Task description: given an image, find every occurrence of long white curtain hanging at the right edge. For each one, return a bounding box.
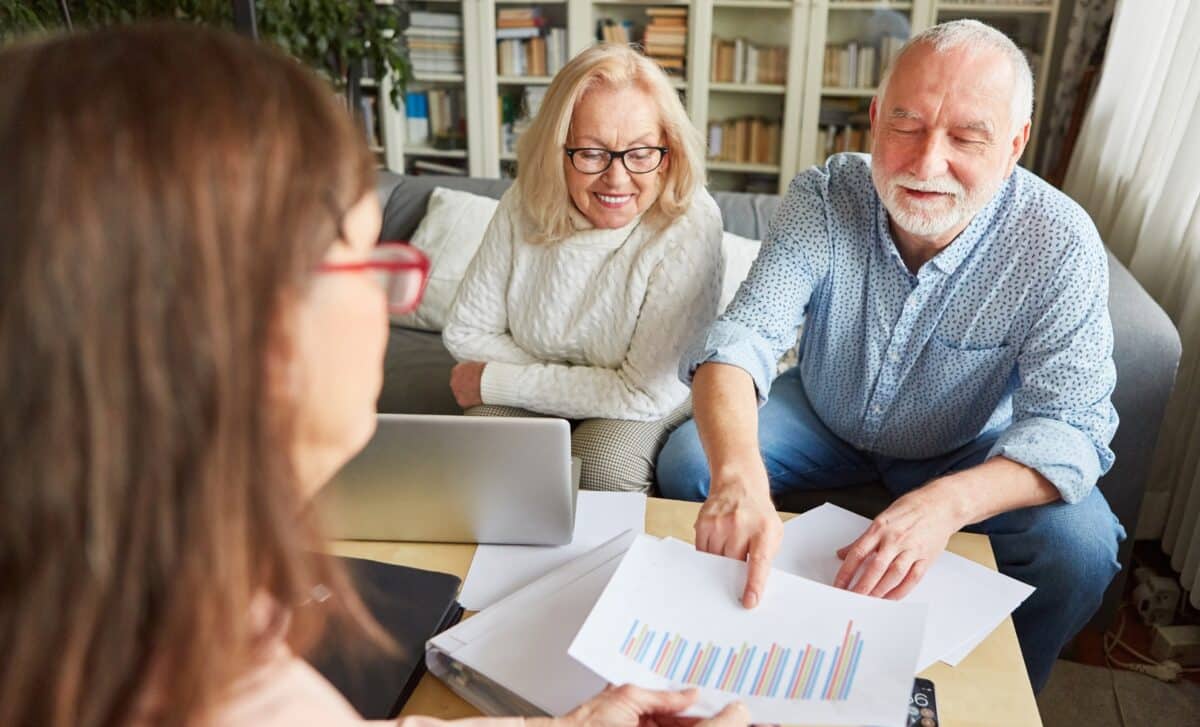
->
[1063,0,1200,607]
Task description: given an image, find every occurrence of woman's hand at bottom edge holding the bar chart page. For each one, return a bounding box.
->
[547,684,750,727]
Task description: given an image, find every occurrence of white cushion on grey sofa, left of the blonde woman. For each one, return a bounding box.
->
[391,187,499,331]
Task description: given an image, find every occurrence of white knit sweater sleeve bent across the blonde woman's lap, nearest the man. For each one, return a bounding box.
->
[481,191,724,421]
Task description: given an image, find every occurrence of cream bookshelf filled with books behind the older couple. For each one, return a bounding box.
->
[374,0,1061,193]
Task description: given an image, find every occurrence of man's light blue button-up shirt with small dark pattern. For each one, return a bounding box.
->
[680,154,1117,503]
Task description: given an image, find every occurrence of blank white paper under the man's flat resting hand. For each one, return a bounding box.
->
[775,503,1033,671]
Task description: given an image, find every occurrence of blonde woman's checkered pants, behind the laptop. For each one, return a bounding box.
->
[464,398,691,492]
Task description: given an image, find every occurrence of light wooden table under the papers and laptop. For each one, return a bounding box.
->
[331,498,1042,727]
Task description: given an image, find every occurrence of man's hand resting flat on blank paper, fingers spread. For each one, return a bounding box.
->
[833,485,965,600]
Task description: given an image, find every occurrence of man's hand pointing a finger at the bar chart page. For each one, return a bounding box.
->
[696,464,784,608]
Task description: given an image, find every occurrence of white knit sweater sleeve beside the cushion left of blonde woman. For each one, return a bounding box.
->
[442,190,538,365]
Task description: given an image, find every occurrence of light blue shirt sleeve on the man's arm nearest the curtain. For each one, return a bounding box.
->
[988,236,1117,503]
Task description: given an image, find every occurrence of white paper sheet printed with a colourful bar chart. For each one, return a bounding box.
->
[569,535,925,726]
